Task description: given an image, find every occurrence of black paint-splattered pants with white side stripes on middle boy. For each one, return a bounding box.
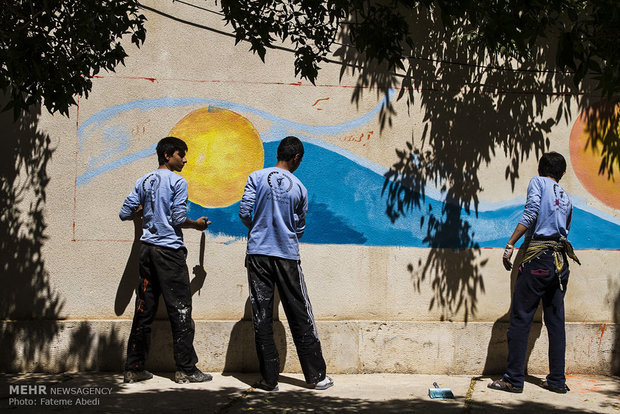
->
[246,254,326,385]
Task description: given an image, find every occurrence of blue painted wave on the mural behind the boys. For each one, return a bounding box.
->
[188,142,620,249]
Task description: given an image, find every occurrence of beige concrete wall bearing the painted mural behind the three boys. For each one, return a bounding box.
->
[0,1,620,373]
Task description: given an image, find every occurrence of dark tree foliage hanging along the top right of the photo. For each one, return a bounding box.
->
[221,0,620,96]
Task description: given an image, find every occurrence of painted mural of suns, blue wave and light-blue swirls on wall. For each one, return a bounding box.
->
[76,92,620,249]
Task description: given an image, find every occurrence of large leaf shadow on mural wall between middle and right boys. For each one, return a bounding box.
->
[336,7,596,372]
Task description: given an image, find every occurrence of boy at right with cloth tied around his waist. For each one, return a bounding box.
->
[489,152,579,393]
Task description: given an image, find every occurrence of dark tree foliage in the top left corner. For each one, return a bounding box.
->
[0,0,146,117]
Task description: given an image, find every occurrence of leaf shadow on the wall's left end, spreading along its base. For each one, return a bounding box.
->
[0,98,124,372]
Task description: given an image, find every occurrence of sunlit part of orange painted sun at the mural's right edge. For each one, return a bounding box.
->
[570,107,620,209]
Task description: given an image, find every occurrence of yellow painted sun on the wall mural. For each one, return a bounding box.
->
[169,106,264,207]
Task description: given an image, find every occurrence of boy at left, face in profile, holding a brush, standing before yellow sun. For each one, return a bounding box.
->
[119,137,212,383]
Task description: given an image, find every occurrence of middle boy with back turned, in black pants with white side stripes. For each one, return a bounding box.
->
[239,136,333,391]
